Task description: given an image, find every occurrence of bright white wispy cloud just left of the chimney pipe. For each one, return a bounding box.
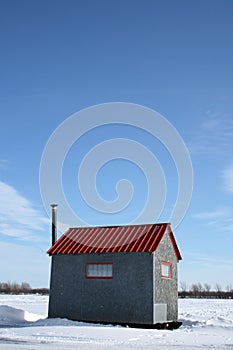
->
[0,181,49,242]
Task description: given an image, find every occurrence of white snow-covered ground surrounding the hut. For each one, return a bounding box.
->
[0,295,233,350]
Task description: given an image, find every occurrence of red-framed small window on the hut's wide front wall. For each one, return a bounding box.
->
[86,262,112,279]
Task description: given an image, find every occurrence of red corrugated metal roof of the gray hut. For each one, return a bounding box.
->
[48,223,181,260]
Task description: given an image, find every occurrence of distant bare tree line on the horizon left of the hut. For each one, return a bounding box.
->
[0,281,49,294]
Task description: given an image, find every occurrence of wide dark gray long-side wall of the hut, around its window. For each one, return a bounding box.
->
[49,253,153,324]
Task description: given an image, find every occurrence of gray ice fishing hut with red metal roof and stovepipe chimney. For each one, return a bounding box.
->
[48,208,181,326]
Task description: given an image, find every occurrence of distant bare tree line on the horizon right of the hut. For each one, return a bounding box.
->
[178,281,233,299]
